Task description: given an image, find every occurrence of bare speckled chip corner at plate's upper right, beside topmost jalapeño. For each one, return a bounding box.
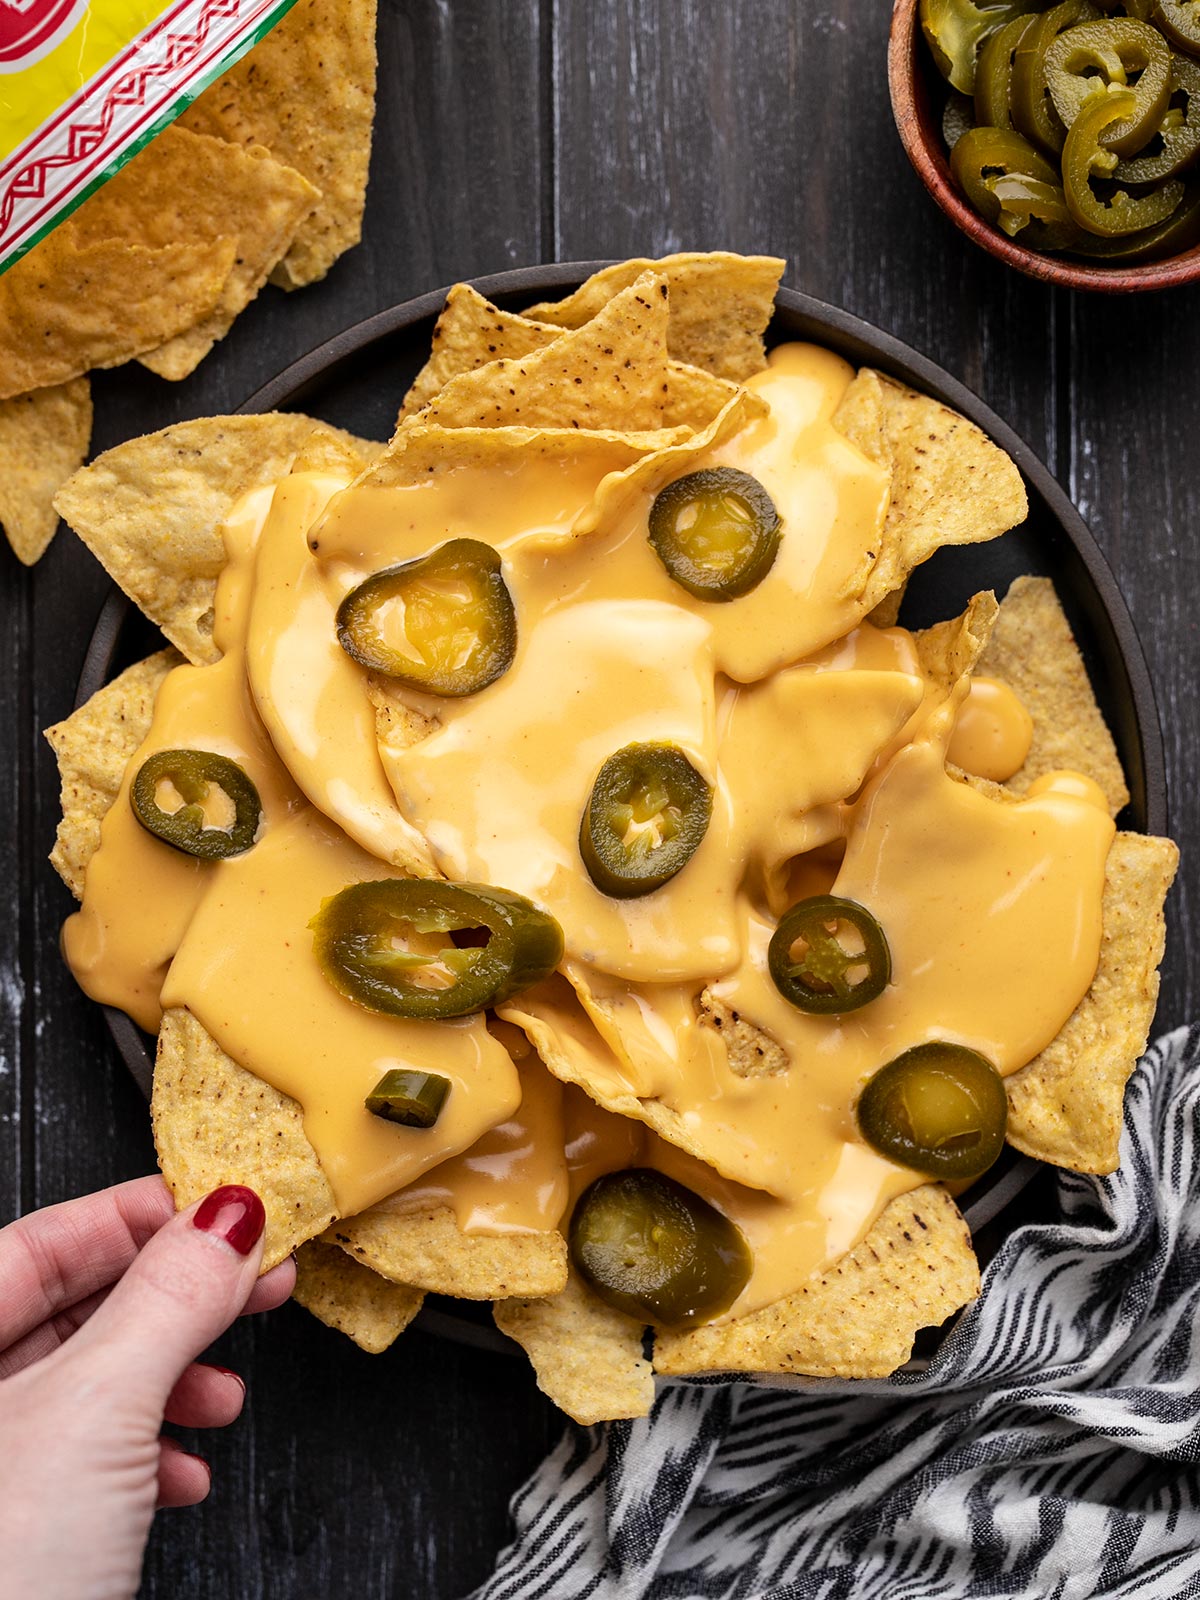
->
[834,368,1029,608]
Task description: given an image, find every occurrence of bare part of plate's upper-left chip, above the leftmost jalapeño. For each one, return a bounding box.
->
[52,419,376,666]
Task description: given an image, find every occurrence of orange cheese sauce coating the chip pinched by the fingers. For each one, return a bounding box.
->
[163,808,520,1216]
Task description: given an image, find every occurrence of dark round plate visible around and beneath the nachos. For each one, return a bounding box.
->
[77,261,1166,1352]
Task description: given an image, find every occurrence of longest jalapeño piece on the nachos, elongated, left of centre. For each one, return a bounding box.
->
[310,878,563,1022]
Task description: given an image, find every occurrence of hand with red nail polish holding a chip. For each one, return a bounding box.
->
[0,1178,296,1600]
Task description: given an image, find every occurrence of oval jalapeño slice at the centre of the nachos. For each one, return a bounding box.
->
[579,744,712,899]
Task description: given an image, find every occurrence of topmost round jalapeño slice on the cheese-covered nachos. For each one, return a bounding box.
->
[650,467,782,600]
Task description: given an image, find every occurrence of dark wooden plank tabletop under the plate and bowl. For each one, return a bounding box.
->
[0,0,1200,1600]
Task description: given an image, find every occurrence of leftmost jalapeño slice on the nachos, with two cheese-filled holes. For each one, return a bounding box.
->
[130,750,262,861]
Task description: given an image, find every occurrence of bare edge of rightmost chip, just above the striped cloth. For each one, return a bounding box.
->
[1005,834,1179,1173]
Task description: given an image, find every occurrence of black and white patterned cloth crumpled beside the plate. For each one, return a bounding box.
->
[475,1029,1200,1600]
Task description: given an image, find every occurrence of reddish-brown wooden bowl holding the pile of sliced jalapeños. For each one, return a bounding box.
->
[888,0,1200,294]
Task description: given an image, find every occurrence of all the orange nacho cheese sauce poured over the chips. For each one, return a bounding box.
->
[64,344,1114,1315]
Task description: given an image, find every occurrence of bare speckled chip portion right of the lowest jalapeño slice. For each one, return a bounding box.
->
[654,1184,979,1378]
